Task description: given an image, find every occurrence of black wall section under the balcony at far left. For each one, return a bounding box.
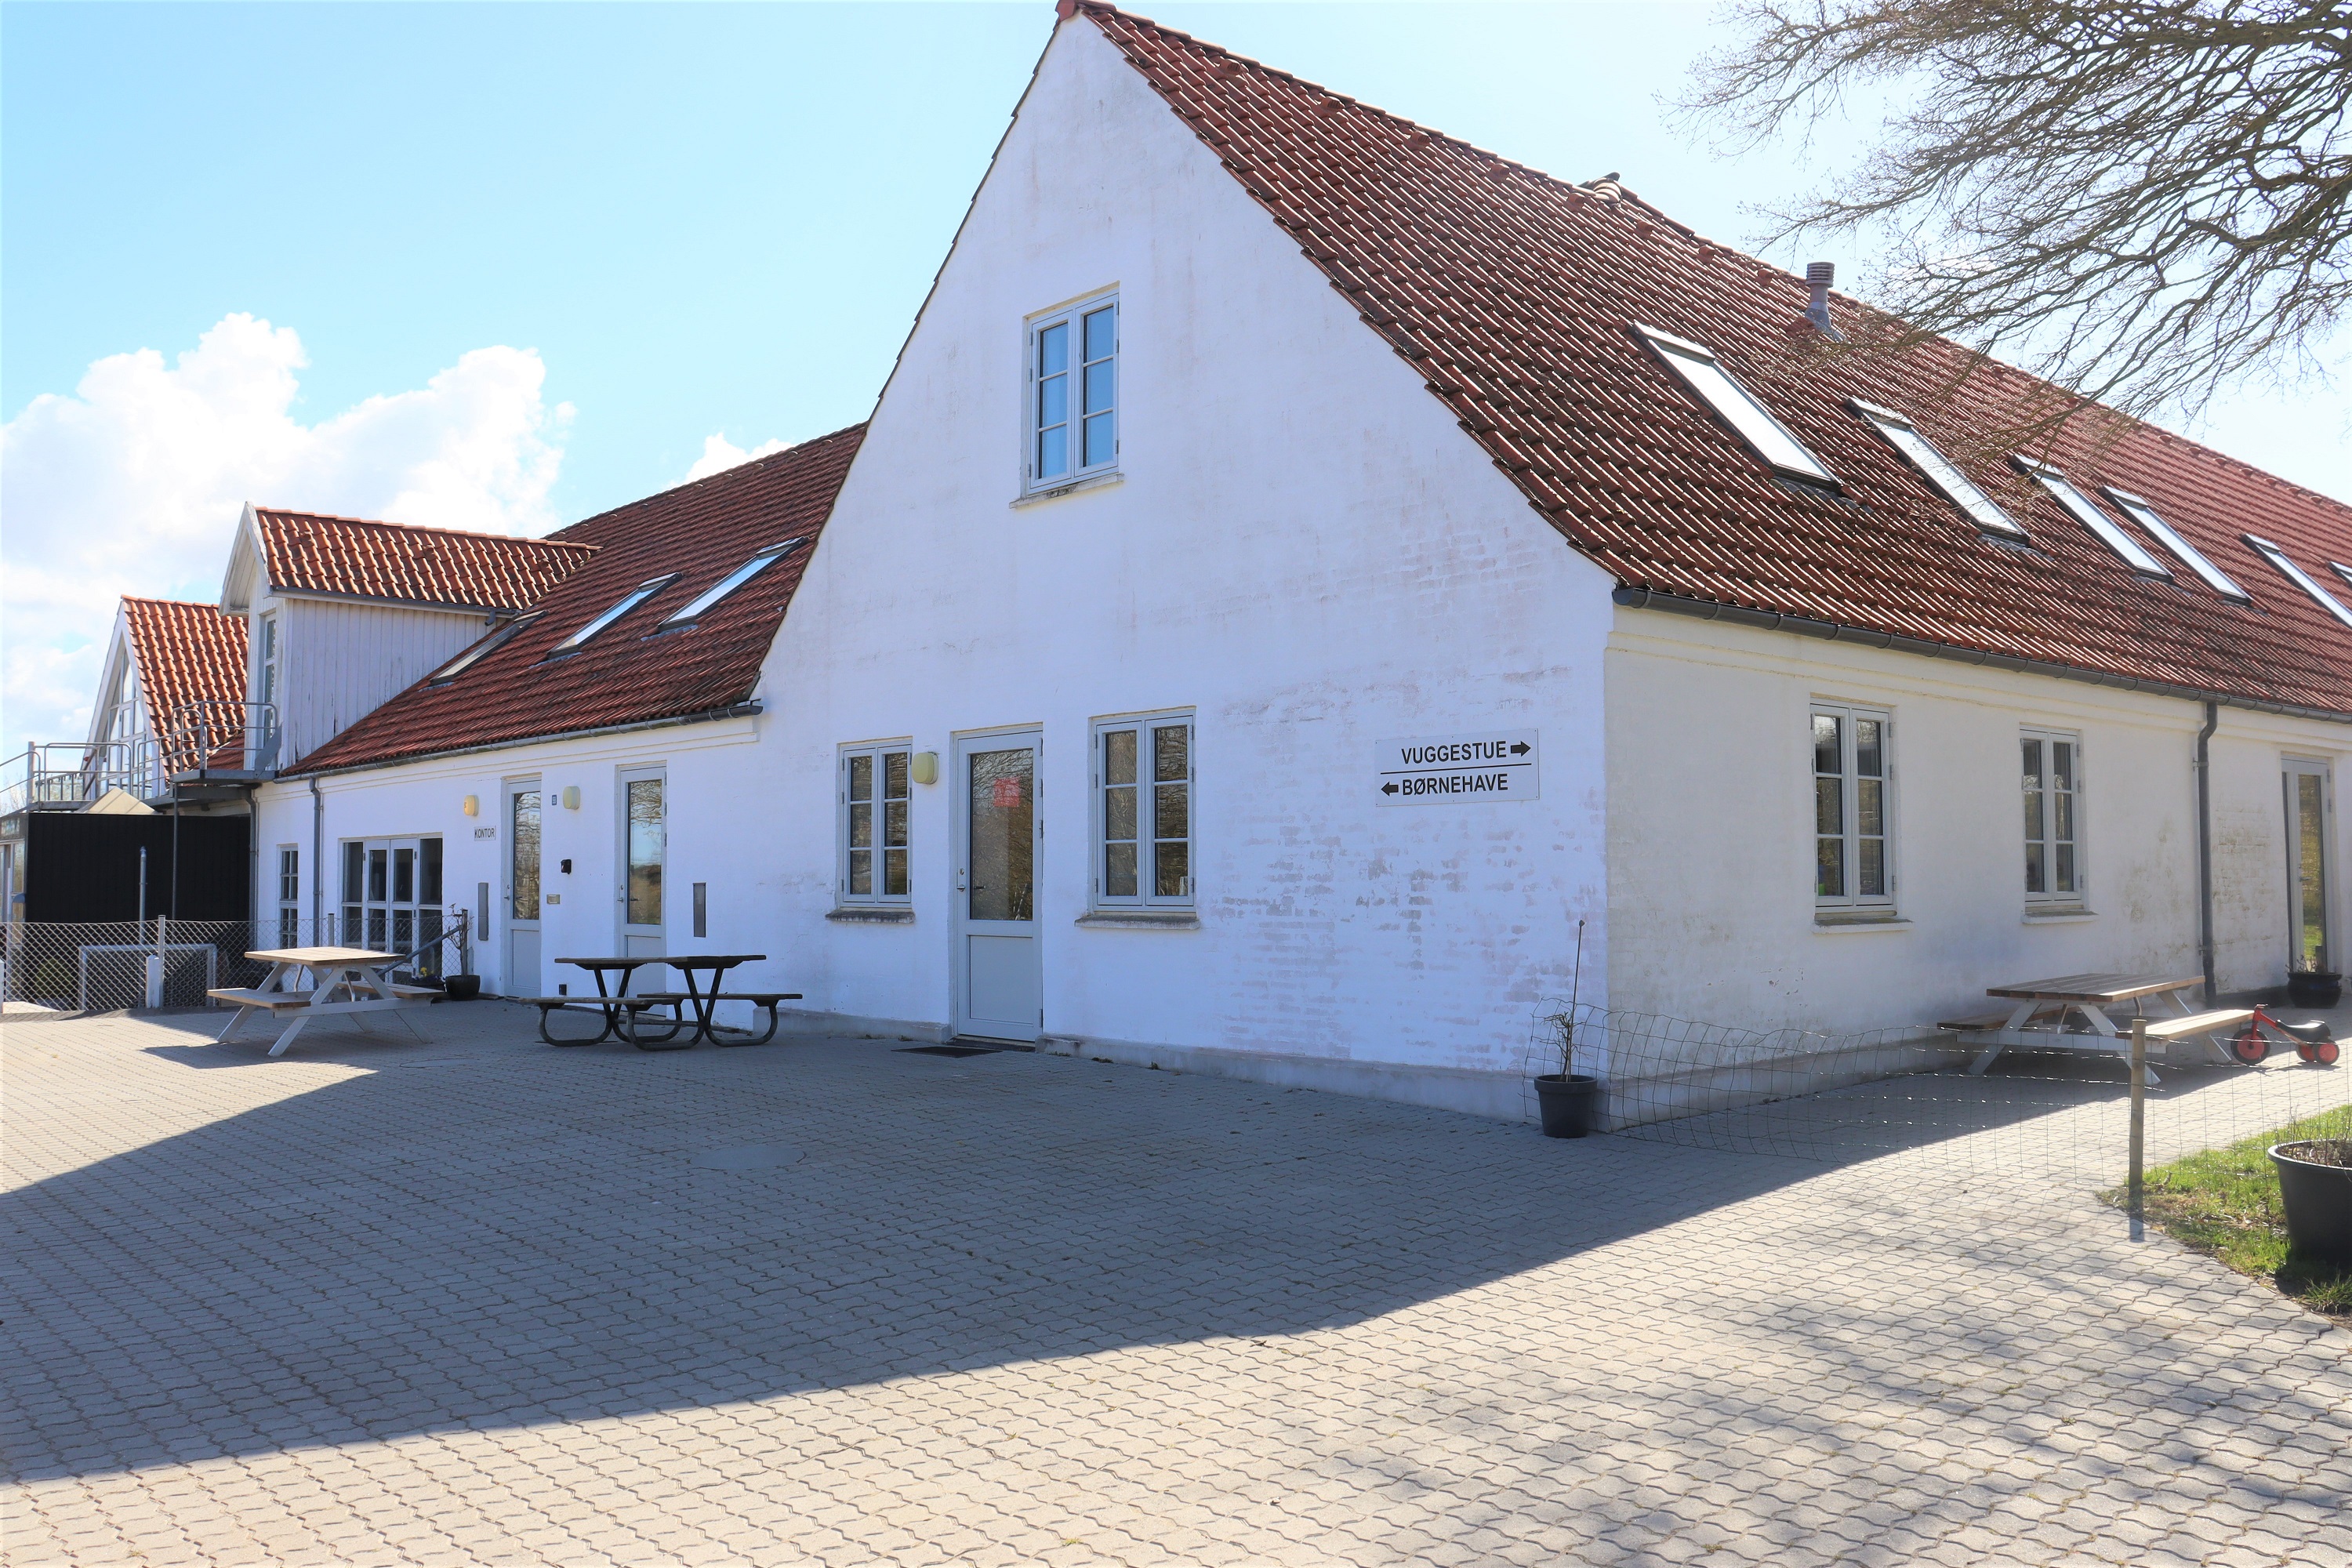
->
[24,811,254,921]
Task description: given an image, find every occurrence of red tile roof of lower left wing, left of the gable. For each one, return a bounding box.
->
[285,426,866,774]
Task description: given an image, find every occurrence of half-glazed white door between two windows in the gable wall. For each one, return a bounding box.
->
[955,731,1044,1041]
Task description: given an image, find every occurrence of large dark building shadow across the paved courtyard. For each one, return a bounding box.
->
[0,1008,2314,1479]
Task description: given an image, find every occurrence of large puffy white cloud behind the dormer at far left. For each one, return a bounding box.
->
[0,315,572,750]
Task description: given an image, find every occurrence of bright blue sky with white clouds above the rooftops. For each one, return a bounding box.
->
[0,0,2352,741]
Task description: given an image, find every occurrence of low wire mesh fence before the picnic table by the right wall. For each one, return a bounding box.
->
[1524,999,2352,1185]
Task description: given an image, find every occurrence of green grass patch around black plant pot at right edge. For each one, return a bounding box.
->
[2103,1107,2352,1314]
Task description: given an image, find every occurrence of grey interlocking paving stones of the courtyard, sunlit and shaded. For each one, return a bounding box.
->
[0,1004,2352,1568]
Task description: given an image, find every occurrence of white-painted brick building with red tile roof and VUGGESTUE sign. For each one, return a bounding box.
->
[216,5,2352,1114]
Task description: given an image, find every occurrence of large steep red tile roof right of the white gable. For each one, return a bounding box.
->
[1063,0,2352,715]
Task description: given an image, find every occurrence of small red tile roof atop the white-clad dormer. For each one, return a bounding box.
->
[254,508,595,612]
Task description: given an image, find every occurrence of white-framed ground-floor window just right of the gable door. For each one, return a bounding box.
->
[1091,710,1195,909]
